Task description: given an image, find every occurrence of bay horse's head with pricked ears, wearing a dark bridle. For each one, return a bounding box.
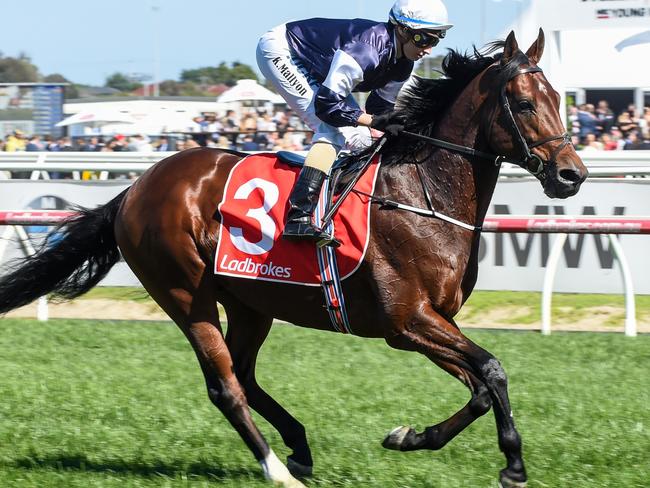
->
[487,29,588,198]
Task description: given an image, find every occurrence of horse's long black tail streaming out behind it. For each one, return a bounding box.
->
[0,190,126,314]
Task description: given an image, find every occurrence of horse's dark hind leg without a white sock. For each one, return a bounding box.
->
[226,303,313,477]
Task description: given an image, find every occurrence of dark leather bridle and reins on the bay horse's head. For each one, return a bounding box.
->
[400,66,573,183]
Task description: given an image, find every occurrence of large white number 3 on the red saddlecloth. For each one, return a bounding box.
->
[229,178,280,256]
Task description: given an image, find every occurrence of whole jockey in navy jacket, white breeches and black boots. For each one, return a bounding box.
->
[257,0,452,243]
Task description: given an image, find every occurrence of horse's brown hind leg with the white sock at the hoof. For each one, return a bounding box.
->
[122,240,304,488]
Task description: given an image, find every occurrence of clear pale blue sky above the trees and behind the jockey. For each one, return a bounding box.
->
[0,0,525,85]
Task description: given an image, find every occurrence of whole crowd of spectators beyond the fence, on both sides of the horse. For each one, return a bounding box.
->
[5,100,650,152]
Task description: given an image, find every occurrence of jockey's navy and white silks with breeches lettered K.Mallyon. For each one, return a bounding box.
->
[257,18,414,150]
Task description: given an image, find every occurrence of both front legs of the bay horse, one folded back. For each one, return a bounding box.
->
[383,304,527,488]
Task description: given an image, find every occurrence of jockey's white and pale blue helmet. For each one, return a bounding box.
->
[389,0,454,32]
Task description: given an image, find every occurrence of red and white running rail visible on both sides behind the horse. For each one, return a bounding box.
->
[0,210,650,234]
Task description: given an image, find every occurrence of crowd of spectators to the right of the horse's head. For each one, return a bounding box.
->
[569,100,650,151]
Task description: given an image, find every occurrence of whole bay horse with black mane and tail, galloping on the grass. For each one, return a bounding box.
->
[0,30,587,487]
